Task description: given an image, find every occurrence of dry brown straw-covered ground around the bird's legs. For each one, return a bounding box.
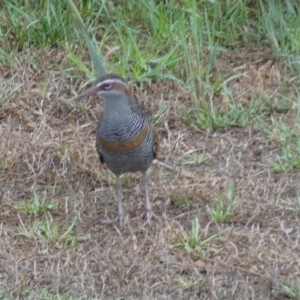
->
[0,52,300,300]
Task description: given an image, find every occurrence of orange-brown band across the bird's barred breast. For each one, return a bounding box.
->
[98,126,149,153]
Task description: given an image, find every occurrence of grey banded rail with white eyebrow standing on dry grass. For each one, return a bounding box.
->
[76,73,159,226]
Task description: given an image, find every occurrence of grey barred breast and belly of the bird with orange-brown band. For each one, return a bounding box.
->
[96,97,157,174]
